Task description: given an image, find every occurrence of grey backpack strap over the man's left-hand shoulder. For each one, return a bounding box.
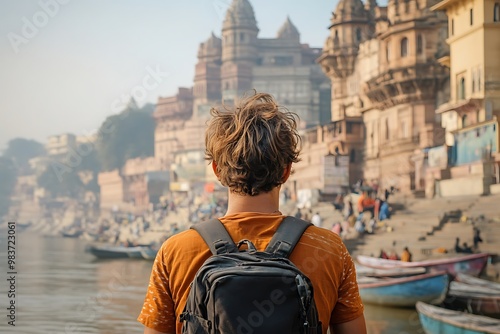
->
[191,218,238,255]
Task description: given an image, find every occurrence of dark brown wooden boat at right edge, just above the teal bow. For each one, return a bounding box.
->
[444,282,500,318]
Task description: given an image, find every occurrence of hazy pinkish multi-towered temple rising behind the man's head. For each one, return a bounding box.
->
[154,0,331,190]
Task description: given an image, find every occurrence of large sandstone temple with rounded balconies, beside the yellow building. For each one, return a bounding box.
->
[295,0,449,194]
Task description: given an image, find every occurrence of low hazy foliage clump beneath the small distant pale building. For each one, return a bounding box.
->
[37,162,84,198]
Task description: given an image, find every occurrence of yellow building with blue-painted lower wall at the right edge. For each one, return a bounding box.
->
[431,0,500,196]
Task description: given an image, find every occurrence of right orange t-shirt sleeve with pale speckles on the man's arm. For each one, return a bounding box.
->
[330,245,364,324]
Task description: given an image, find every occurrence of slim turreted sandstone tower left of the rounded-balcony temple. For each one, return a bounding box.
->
[318,0,376,184]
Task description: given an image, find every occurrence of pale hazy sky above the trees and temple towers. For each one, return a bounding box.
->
[0,0,337,150]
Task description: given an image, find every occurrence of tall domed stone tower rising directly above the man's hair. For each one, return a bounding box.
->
[221,0,259,103]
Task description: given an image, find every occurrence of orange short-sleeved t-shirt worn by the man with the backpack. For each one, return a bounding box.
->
[137,212,363,334]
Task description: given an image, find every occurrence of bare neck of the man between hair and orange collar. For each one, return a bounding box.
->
[226,187,280,215]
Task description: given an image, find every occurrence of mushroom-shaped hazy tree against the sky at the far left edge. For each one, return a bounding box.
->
[3,138,45,174]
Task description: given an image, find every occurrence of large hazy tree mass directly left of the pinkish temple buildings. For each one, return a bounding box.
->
[97,106,155,171]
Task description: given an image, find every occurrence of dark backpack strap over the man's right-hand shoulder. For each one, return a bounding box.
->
[266,216,312,258]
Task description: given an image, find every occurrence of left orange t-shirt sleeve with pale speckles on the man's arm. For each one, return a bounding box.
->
[137,244,175,333]
